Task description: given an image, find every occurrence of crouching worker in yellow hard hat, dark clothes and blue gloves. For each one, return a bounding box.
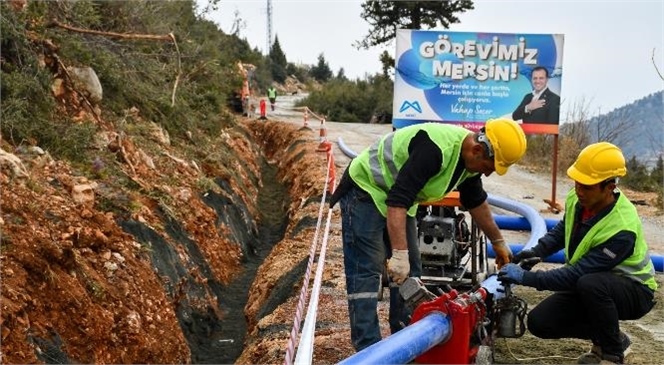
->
[498,142,657,364]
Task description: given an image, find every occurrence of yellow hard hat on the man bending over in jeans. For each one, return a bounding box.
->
[484,118,526,175]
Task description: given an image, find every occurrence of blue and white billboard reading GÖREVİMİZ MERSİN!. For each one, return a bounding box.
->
[392,29,564,134]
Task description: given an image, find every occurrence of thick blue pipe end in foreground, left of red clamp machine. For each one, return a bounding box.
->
[339,312,451,365]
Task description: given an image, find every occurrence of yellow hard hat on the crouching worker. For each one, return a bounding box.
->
[567,142,627,185]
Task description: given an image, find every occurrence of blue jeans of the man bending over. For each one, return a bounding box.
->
[339,187,422,351]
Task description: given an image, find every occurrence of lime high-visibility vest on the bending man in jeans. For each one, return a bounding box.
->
[349,123,477,217]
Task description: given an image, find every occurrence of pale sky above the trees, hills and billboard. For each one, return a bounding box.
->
[197,0,664,116]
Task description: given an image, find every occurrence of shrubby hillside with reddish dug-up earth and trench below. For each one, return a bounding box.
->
[0,1,324,363]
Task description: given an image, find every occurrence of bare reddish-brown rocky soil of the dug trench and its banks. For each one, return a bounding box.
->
[0,118,325,364]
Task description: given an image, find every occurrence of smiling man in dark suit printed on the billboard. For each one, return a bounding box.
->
[512,66,560,124]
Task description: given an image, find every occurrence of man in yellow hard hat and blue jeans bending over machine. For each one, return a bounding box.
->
[330,119,526,351]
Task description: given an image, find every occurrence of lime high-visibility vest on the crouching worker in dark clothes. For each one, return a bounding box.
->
[564,189,657,290]
